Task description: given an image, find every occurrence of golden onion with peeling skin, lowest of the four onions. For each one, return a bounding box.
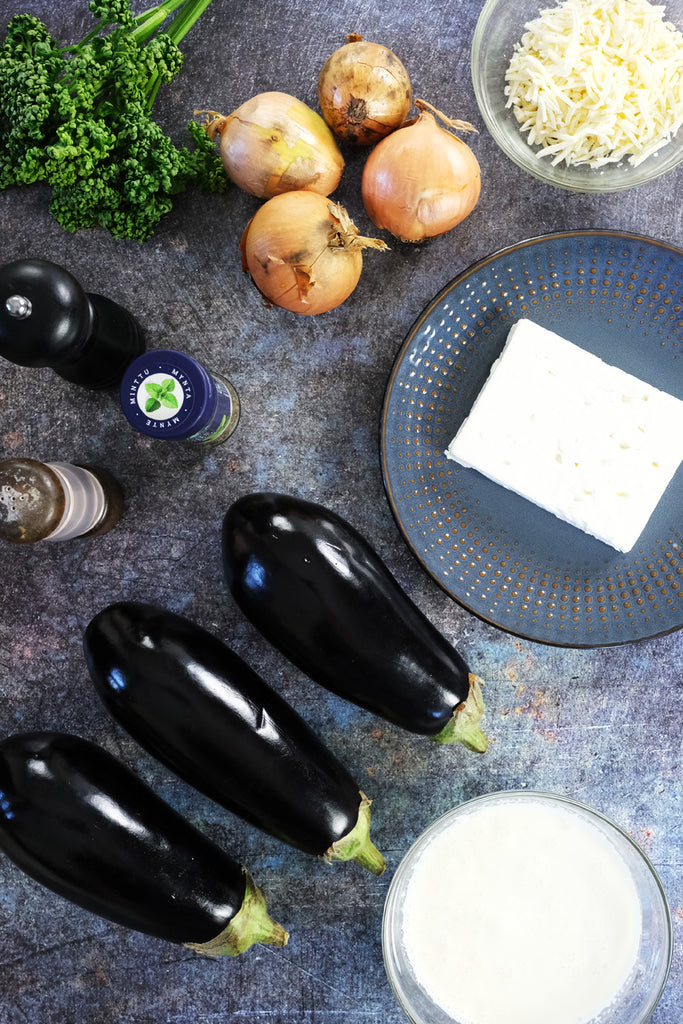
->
[240,191,387,314]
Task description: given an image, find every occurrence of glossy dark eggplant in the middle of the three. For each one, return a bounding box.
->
[83,601,385,874]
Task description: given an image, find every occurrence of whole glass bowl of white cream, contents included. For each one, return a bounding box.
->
[382,790,673,1024]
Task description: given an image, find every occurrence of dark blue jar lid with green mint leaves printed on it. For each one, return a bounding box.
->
[120,348,216,440]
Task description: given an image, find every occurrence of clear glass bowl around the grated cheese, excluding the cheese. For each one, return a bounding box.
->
[471,0,683,193]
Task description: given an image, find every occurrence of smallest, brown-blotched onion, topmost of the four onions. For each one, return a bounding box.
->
[317,35,413,145]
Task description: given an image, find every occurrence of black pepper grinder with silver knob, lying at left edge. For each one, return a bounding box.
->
[0,259,144,390]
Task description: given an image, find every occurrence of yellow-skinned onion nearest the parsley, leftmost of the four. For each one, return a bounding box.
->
[200,92,344,199]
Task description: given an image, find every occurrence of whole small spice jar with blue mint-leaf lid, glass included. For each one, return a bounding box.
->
[120,348,240,445]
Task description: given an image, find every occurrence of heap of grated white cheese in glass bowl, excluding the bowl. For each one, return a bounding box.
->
[505,0,683,167]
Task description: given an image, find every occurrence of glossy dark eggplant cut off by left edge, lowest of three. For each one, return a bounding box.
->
[0,732,288,956]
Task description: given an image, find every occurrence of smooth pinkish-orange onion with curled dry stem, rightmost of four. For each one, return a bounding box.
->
[360,99,481,242]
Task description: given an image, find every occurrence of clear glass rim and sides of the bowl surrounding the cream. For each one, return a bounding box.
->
[382,790,673,1024]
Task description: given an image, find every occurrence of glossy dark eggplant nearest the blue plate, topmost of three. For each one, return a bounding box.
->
[222,493,488,752]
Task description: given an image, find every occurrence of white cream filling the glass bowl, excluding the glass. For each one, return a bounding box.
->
[402,800,641,1024]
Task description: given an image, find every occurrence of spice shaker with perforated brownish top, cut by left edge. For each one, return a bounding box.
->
[0,458,123,544]
